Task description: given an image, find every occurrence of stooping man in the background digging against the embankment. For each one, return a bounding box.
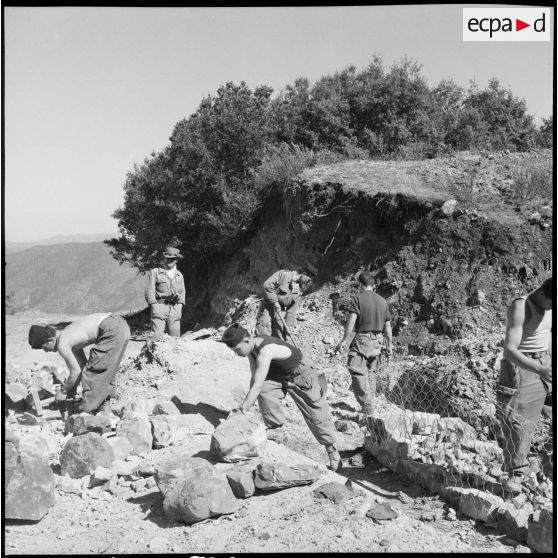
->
[255,269,312,340]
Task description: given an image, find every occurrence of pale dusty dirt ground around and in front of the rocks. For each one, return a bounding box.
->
[5,326,513,555]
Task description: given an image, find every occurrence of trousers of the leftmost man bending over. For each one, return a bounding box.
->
[68,314,130,413]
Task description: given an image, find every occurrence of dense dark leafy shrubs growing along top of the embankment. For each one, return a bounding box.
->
[108,56,553,275]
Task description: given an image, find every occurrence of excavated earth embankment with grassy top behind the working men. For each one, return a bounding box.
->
[195,151,553,460]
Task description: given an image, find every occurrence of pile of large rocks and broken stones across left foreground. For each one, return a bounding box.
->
[5,380,364,524]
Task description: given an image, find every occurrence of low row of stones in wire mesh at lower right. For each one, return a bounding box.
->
[365,398,553,552]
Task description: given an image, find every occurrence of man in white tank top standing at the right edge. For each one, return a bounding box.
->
[496,278,555,494]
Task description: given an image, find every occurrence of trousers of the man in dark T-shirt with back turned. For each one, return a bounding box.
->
[347,332,383,416]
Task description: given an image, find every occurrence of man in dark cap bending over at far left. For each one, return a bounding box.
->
[29,314,130,413]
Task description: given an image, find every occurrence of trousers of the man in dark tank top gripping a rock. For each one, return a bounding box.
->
[258,368,335,446]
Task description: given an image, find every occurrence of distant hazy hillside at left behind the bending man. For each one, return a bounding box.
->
[6,242,145,314]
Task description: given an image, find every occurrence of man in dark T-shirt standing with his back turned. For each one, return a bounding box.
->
[337,271,392,416]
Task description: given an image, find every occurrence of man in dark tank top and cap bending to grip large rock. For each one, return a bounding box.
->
[221,323,341,471]
